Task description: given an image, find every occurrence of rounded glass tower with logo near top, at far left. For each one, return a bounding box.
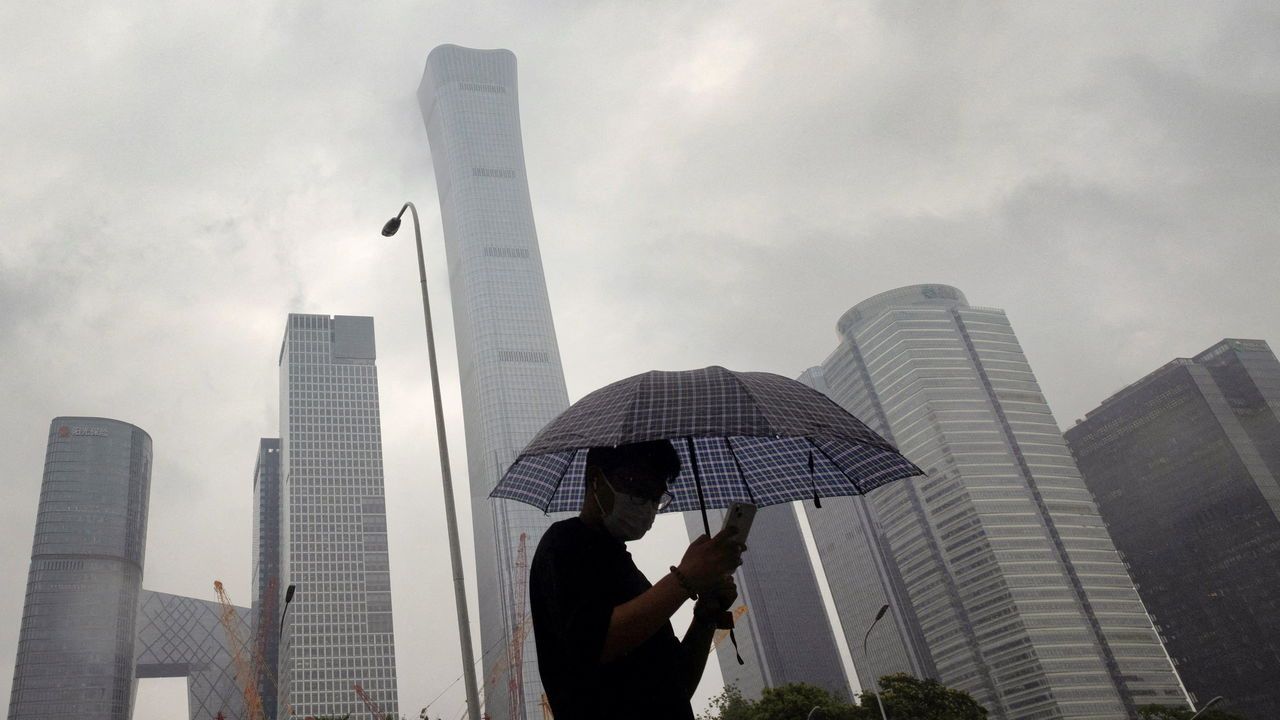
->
[9,418,151,720]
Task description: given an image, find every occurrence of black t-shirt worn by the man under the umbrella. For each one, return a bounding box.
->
[529,518,694,720]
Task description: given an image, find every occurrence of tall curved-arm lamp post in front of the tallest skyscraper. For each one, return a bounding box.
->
[383,202,480,720]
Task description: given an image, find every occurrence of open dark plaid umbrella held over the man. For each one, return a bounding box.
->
[490,366,924,534]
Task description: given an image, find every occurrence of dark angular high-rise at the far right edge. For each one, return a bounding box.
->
[1065,340,1280,717]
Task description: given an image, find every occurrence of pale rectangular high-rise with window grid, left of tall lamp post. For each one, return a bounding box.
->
[276,314,399,719]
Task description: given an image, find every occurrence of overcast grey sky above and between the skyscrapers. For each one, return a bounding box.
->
[0,1,1280,720]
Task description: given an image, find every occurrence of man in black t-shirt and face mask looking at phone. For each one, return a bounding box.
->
[529,439,746,720]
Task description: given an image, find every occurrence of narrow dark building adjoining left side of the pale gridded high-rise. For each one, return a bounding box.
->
[250,438,283,720]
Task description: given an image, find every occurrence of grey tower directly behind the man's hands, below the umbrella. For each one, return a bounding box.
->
[684,500,852,700]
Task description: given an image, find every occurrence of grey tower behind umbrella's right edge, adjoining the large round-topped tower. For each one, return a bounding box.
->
[799,366,937,689]
